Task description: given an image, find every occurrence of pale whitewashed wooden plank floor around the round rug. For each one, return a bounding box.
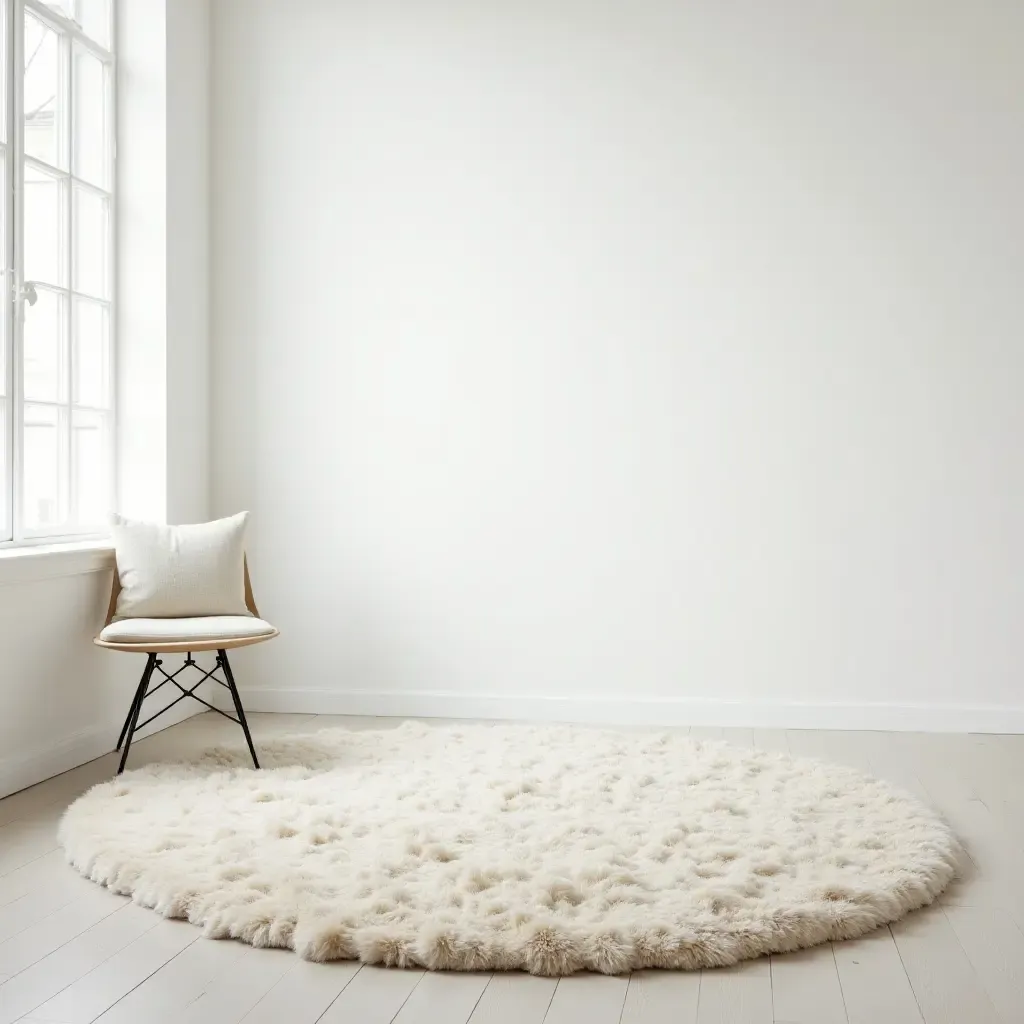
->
[0,714,1024,1024]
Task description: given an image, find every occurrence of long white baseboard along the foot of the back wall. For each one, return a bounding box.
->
[226,687,1024,733]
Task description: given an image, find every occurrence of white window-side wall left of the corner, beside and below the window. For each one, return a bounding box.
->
[0,0,210,796]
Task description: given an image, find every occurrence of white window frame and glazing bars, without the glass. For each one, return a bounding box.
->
[0,0,118,550]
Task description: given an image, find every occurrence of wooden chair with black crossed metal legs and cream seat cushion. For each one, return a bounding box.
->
[92,562,279,775]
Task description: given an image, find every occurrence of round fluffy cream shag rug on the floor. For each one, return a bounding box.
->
[60,723,957,975]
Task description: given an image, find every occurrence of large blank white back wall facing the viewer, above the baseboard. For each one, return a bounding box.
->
[211,0,1024,728]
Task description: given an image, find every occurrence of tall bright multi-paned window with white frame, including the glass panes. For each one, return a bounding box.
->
[0,0,115,544]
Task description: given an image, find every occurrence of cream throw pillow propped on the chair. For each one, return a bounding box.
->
[111,512,251,618]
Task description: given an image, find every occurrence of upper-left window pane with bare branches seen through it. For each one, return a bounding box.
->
[22,11,68,168]
